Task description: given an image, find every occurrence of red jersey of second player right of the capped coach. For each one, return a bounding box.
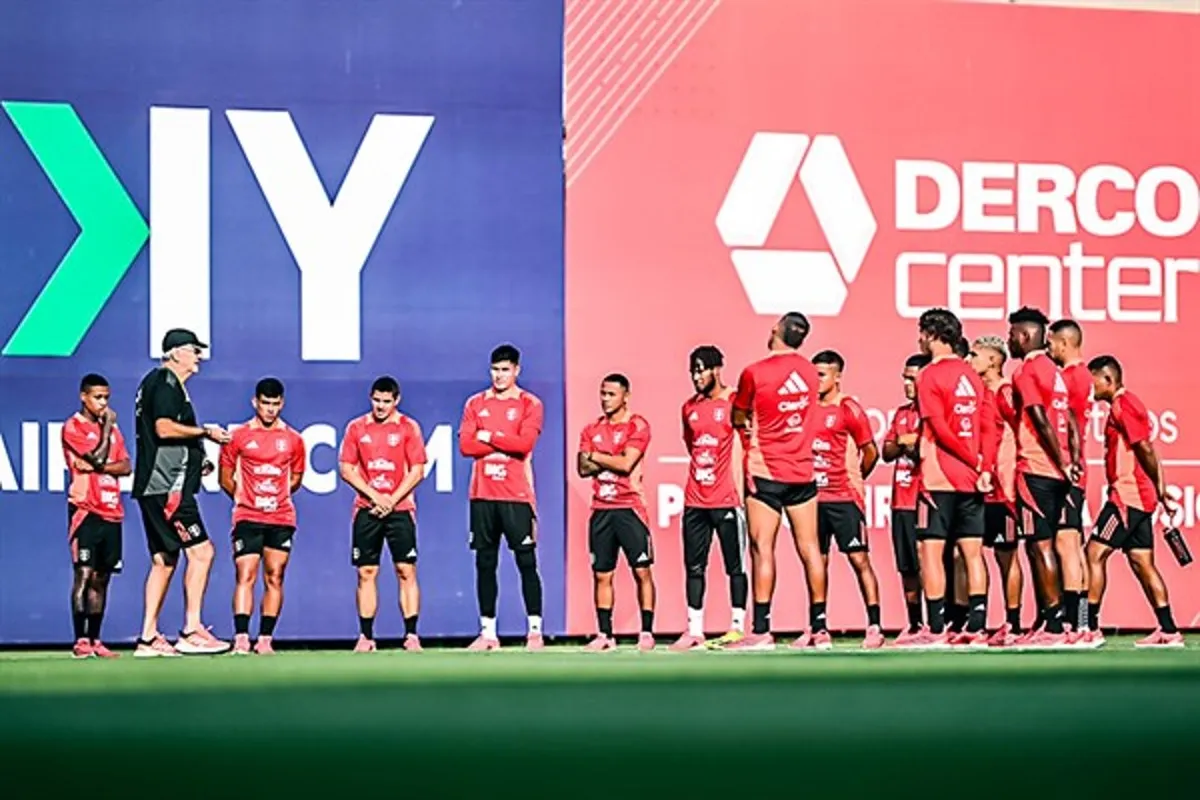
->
[338,411,427,511]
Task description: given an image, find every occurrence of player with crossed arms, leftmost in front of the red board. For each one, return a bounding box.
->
[575,373,654,652]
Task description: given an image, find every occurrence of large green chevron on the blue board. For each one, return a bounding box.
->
[0,102,150,357]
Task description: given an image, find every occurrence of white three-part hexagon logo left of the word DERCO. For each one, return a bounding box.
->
[716,131,878,317]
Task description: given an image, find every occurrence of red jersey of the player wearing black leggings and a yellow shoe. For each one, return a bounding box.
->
[680,389,742,509]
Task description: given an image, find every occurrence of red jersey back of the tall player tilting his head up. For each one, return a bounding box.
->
[733,350,818,483]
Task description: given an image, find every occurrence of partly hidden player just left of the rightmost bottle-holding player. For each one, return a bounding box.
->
[1049,319,1092,637]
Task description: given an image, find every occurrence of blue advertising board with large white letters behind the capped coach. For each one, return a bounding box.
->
[0,0,565,643]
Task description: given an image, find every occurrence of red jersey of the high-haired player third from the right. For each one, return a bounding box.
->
[1013,350,1070,481]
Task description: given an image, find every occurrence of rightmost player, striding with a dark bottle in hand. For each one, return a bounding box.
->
[1087,355,1183,648]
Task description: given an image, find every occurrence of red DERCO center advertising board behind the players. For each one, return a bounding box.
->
[566,0,1200,633]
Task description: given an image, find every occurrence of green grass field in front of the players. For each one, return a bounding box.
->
[0,638,1200,798]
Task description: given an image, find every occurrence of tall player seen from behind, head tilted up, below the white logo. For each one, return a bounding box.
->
[727,312,833,650]
